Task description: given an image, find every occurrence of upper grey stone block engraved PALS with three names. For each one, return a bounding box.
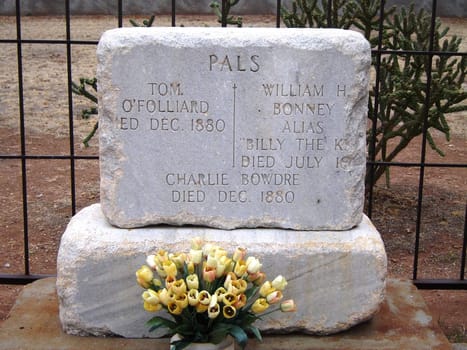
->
[98,28,370,230]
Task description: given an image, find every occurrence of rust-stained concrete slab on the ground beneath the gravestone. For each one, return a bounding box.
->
[0,278,454,350]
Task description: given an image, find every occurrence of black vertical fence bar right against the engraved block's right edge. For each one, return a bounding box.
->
[367,0,386,219]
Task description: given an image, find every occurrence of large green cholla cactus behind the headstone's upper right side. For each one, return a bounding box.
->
[282,0,467,186]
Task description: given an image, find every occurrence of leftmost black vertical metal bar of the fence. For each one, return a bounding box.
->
[16,0,30,275]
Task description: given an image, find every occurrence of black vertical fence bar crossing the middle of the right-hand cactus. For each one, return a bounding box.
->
[413,0,437,280]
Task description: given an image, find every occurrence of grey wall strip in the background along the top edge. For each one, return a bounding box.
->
[0,0,467,17]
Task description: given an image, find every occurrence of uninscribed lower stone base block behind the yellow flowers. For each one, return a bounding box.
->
[57,204,386,337]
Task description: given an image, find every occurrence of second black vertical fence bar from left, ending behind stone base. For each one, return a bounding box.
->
[65,0,76,215]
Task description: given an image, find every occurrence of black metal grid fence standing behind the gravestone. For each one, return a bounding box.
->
[0,0,467,289]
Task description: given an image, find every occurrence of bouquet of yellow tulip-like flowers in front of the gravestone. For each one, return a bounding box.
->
[136,238,296,350]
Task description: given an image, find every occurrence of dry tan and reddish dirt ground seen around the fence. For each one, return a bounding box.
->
[0,16,467,342]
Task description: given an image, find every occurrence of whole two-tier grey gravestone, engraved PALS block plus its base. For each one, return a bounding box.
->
[57,28,386,337]
